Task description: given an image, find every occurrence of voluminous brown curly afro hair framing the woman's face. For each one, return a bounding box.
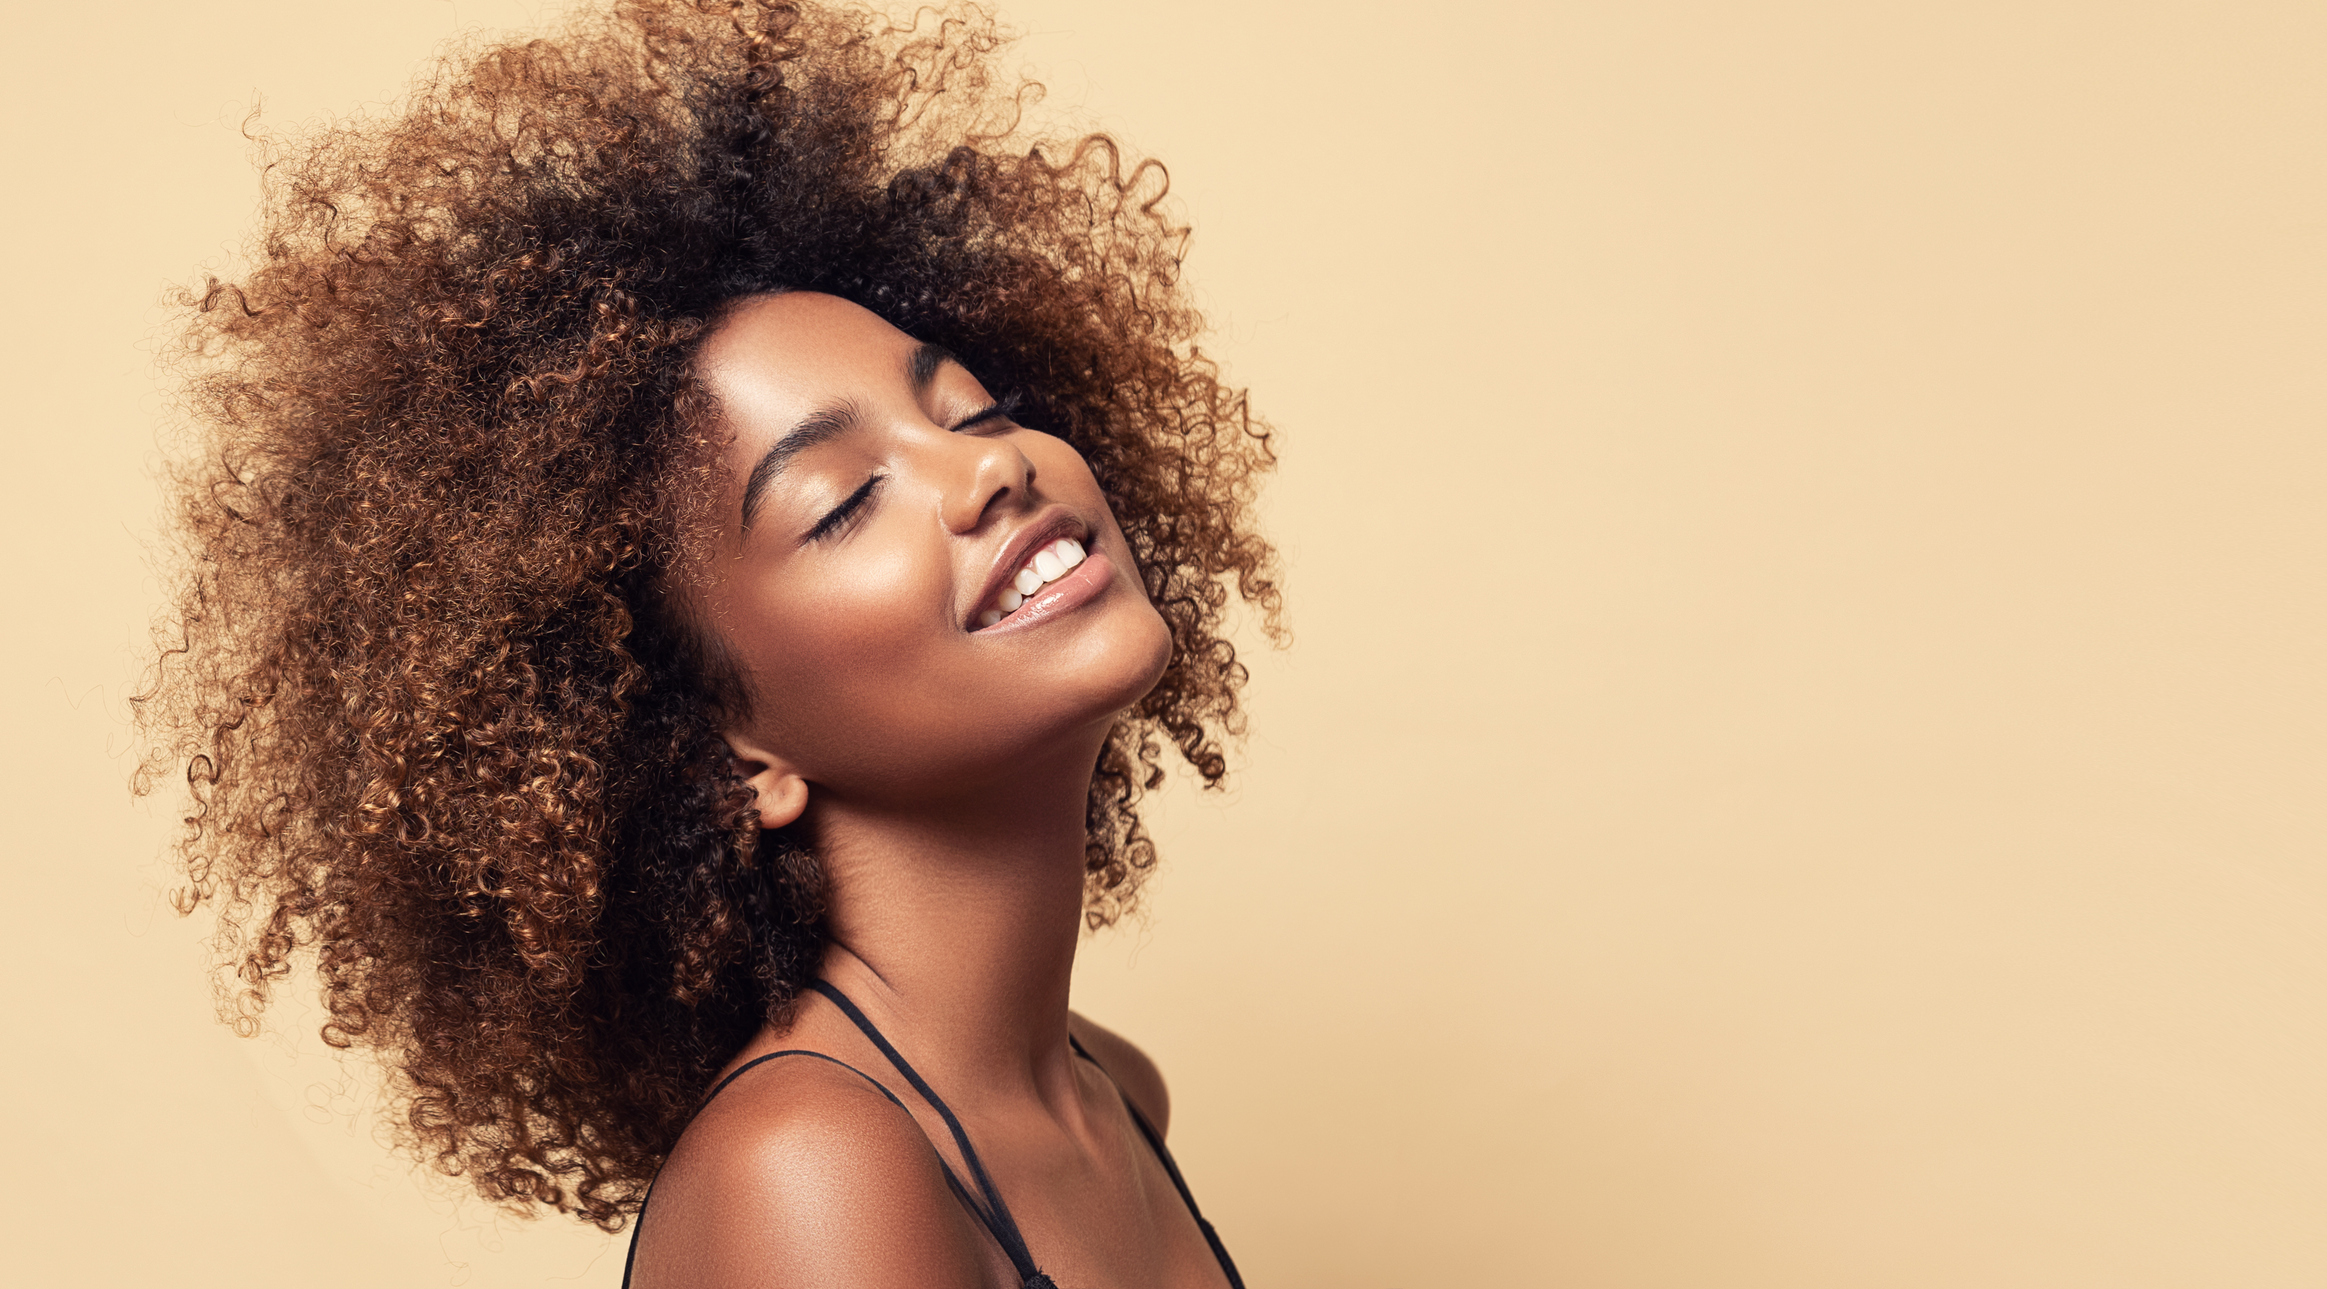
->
[140,0,1280,1229]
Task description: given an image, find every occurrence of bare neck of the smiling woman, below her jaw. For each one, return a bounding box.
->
[812,730,1096,1103]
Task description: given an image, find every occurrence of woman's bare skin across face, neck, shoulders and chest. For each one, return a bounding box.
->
[633,293,1226,1289]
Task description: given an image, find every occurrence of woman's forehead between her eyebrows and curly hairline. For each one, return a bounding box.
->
[698,291,915,423]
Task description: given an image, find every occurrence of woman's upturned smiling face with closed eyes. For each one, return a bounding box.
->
[700,291,1170,805]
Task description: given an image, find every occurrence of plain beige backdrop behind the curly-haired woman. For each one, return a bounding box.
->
[0,0,2327,1289]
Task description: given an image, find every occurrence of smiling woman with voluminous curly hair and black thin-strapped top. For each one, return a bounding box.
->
[133,0,1278,1289]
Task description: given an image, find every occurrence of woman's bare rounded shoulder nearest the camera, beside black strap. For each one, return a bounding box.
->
[633,1056,987,1289]
